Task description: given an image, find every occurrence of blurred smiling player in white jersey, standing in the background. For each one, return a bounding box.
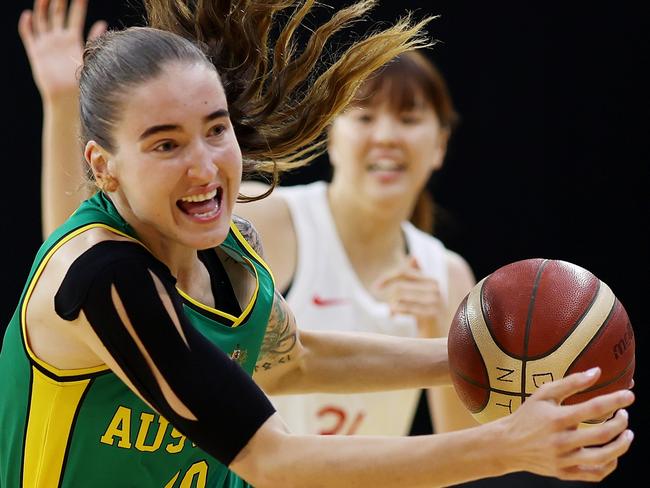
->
[235,51,475,435]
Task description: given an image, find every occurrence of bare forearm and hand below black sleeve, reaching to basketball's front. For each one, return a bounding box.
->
[230,371,634,488]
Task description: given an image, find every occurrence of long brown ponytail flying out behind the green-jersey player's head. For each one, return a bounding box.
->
[145,0,431,201]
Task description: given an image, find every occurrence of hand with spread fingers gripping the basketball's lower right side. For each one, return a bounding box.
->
[496,368,634,481]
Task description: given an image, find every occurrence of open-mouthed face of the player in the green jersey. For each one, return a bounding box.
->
[95,63,242,249]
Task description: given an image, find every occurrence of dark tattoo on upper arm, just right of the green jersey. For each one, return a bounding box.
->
[255,290,298,371]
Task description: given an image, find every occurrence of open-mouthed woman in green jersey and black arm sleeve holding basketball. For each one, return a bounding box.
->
[5,0,633,487]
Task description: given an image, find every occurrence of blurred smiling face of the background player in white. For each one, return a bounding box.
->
[328,97,447,208]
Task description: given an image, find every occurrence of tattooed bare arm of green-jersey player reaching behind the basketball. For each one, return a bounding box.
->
[254,291,451,395]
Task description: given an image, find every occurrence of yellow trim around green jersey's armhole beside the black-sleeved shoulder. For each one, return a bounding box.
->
[20,223,137,377]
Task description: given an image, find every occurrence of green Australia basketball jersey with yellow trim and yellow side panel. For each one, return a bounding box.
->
[0,193,274,488]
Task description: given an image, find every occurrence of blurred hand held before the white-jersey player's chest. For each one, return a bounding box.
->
[373,257,447,337]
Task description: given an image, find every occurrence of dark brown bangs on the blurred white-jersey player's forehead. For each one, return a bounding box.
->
[350,51,458,131]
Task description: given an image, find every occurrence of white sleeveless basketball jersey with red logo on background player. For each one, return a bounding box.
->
[272,182,447,435]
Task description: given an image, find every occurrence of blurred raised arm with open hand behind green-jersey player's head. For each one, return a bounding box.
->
[18,0,106,237]
